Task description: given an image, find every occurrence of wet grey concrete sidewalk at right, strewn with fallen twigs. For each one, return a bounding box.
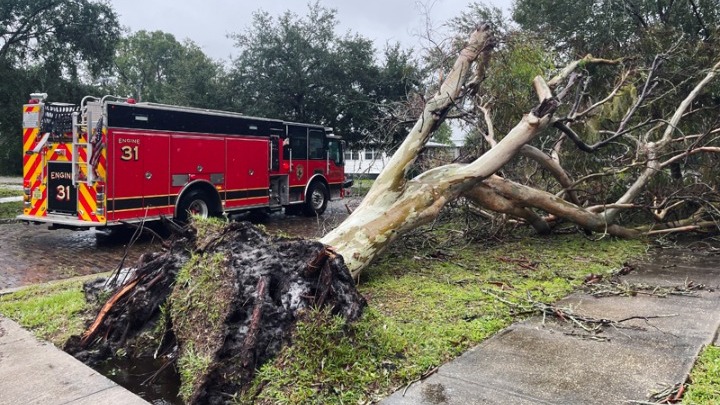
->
[383,246,720,405]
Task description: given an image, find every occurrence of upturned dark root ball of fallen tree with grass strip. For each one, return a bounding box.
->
[66,221,366,404]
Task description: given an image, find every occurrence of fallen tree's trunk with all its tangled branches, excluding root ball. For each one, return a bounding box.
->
[320,26,720,277]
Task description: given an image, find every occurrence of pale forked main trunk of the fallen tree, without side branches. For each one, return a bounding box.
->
[320,26,557,278]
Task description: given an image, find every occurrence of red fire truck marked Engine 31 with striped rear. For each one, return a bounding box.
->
[18,94,346,229]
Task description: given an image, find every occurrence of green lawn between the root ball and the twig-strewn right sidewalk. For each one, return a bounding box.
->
[245,229,645,404]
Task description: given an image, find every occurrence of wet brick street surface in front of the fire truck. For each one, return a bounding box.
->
[0,199,357,290]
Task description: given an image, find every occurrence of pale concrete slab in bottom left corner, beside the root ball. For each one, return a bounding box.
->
[0,316,148,405]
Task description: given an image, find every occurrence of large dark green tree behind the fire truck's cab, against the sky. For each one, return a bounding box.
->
[231,3,419,147]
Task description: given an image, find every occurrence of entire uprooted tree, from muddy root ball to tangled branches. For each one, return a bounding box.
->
[69,25,720,403]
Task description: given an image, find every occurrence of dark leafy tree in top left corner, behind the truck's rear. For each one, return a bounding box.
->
[0,0,120,174]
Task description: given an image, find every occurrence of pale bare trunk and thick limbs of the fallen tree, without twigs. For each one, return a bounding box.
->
[320,32,720,279]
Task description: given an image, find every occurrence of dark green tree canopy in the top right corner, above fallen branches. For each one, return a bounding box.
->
[512,0,720,58]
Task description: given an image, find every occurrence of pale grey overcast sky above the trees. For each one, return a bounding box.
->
[110,0,512,60]
